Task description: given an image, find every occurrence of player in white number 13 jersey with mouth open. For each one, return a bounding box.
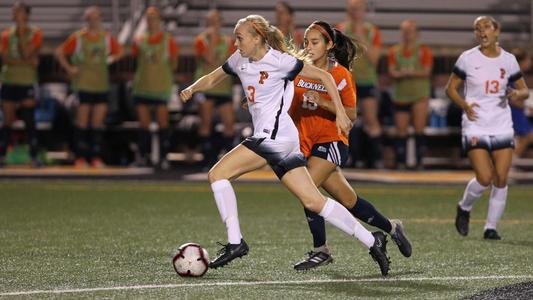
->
[446,16,529,240]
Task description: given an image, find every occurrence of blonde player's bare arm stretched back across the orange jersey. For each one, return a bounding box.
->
[300,64,352,135]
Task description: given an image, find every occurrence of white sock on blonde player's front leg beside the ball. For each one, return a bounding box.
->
[211,179,242,244]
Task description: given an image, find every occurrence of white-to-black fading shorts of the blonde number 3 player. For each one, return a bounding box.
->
[241,137,307,179]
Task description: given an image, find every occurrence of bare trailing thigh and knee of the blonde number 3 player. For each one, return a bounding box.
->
[281,167,326,213]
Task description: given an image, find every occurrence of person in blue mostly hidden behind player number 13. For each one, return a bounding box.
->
[509,48,533,157]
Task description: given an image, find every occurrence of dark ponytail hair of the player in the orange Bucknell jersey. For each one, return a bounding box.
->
[309,21,361,70]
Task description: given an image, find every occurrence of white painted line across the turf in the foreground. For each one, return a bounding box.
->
[0,275,533,296]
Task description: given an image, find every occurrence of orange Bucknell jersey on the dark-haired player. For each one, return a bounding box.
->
[289,63,356,157]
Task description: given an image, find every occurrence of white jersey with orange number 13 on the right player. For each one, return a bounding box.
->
[453,47,522,135]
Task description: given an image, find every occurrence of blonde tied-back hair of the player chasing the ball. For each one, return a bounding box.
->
[235,15,308,61]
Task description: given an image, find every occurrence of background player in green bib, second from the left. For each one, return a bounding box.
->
[55,6,123,168]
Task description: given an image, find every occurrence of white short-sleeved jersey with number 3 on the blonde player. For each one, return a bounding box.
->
[222,49,303,139]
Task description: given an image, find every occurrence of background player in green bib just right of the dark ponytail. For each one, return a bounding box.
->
[337,0,383,168]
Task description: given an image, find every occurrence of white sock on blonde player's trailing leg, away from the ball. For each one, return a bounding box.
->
[319,198,375,248]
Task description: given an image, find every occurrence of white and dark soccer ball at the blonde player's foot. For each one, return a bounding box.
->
[172,243,209,277]
